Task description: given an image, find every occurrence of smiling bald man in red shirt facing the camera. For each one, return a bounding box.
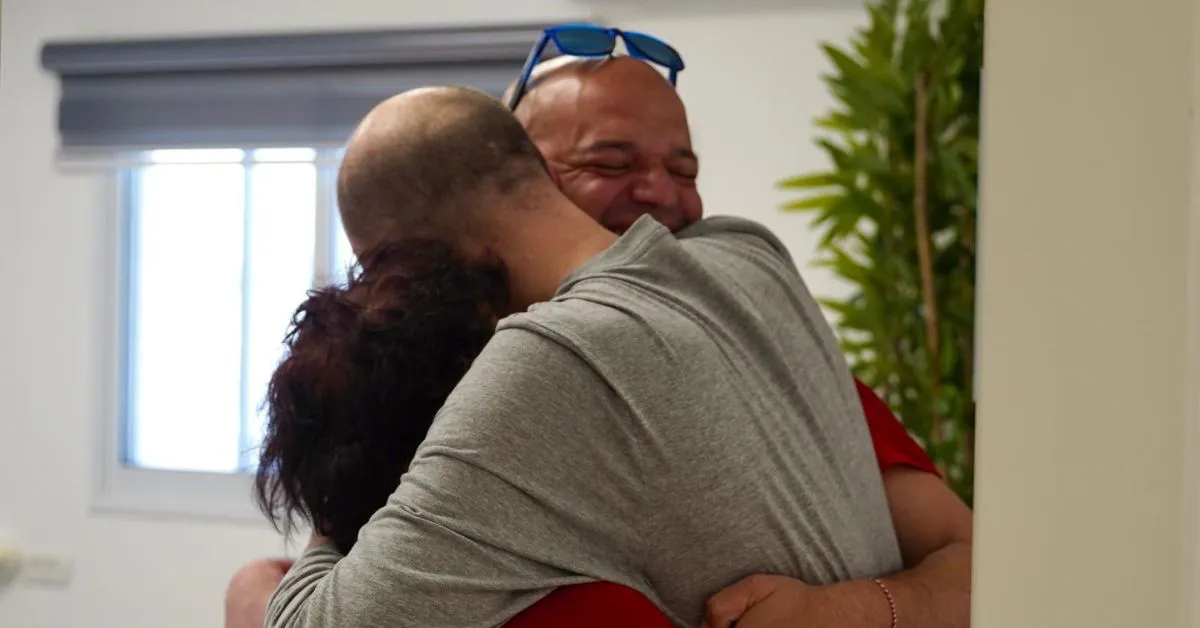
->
[503,56,973,628]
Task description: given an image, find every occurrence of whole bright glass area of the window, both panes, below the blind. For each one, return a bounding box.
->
[121,148,352,473]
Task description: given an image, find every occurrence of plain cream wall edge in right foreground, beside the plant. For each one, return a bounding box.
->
[973,0,1200,628]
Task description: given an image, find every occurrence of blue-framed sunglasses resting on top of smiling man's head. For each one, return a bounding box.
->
[509,24,683,109]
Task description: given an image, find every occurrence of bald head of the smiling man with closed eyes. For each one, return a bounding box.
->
[505,56,703,233]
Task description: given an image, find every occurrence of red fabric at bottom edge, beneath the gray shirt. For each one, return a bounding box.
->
[504,582,673,628]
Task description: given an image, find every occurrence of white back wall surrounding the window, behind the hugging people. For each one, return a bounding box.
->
[0,0,862,628]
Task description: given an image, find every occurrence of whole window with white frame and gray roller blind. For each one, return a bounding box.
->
[42,24,547,521]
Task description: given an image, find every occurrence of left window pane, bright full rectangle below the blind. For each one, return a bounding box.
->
[126,158,245,472]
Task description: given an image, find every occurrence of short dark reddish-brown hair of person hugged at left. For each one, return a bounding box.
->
[254,239,509,552]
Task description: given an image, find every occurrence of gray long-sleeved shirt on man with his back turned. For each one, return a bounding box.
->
[268,217,901,628]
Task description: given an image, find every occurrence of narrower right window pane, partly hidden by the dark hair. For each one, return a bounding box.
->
[241,162,317,468]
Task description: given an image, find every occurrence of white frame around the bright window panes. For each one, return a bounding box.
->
[90,146,340,524]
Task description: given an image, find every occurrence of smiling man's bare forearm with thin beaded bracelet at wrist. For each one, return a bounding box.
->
[828,542,971,628]
